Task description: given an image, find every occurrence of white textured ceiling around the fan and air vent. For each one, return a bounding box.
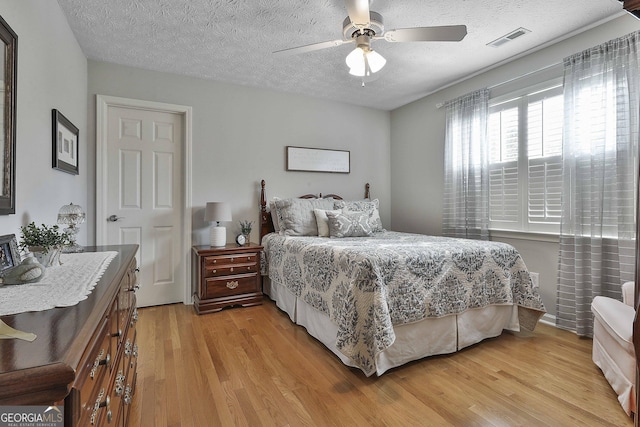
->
[58,0,622,110]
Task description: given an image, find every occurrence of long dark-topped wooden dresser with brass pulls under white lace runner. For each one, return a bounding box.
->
[0,245,138,427]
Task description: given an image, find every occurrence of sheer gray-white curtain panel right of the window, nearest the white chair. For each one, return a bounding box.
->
[556,32,640,336]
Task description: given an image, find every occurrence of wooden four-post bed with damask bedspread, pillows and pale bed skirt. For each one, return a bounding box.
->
[260,181,545,376]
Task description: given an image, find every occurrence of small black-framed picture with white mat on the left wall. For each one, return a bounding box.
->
[51,109,79,175]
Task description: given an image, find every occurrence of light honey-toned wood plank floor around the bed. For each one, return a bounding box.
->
[130,300,633,427]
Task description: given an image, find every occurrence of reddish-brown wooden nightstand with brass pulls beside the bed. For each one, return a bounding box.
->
[191,243,262,314]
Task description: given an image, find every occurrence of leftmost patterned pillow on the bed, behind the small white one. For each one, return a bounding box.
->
[274,198,334,236]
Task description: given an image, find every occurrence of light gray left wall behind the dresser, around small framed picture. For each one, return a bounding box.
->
[0,0,87,244]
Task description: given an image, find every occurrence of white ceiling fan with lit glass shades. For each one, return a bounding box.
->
[273,0,467,77]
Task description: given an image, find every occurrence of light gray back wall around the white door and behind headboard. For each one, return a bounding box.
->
[88,60,390,244]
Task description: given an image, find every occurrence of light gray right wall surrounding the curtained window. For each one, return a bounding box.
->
[391,15,640,315]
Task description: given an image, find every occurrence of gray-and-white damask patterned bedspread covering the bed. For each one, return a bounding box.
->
[262,231,545,375]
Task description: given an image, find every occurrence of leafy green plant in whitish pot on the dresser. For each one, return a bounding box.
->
[20,222,70,267]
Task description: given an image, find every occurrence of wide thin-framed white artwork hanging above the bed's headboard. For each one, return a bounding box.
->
[287,146,351,173]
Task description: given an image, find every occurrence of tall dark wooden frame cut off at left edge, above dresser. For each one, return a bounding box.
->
[0,16,18,215]
